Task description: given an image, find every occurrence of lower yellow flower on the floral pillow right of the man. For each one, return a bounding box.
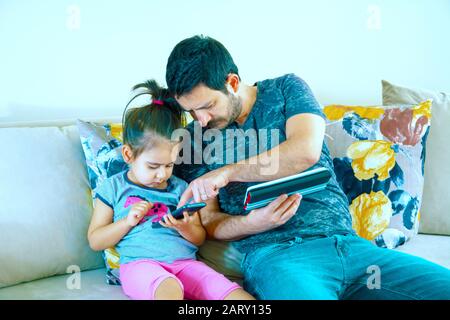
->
[349,191,392,240]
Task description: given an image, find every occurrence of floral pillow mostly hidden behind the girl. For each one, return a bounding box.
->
[77,120,128,285]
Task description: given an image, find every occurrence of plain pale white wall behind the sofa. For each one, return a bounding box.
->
[0,0,450,122]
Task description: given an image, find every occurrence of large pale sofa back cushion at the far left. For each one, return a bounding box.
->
[0,126,103,287]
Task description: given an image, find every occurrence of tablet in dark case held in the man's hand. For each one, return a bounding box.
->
[244,167,331,211]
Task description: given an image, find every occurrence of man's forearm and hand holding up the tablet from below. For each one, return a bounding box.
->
[200,194,301,241]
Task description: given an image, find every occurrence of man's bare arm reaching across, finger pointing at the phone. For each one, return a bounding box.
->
[178,113,325,207]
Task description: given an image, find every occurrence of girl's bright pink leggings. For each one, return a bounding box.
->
[120,259,241,300]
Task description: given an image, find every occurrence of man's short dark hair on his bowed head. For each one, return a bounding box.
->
[166,35,239,96]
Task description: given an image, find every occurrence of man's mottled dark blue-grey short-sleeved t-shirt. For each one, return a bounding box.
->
[174,74,355,253]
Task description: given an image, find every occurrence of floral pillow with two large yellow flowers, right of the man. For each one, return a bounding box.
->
[324,100,431,248]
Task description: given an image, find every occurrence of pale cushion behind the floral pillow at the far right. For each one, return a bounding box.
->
[382,80,450,235]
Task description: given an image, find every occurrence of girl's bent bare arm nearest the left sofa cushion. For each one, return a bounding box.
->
[88,198,132,251]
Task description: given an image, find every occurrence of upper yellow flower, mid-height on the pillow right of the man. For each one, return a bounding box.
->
[347,140,395,181]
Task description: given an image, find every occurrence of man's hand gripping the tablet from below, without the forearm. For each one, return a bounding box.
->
[246,194,302,234]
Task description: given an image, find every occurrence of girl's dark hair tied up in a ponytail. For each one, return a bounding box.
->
[122,80,186,157]
